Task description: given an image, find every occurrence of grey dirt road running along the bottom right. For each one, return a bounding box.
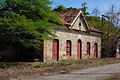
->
[29,63,120,80]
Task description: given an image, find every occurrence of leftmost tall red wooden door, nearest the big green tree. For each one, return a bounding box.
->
[52,40,59,60]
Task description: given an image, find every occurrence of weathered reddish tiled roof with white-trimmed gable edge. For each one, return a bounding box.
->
[59,9,102,33]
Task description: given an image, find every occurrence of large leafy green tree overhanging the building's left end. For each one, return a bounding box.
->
[0,0,62,47]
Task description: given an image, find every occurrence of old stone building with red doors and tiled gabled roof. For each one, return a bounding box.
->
[43,9,102,62]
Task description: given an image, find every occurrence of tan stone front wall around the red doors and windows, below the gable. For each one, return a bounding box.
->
[43,31,101,62]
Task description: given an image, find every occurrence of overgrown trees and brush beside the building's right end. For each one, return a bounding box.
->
[86,16,120,57]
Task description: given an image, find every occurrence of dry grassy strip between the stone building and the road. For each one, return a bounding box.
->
[0,58,120,80]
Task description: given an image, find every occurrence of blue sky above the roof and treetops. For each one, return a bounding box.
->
[50,0,120,15]
